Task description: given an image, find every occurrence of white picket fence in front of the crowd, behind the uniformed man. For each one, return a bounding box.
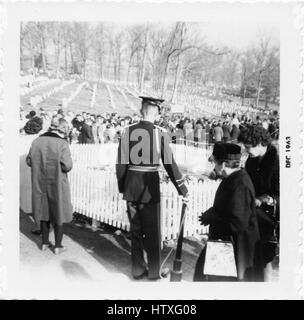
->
[69,144,218,240]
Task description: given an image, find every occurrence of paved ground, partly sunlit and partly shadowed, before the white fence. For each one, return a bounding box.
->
[20,212,201,282]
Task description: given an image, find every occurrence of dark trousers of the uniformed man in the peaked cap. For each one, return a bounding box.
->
[127,202,161,279]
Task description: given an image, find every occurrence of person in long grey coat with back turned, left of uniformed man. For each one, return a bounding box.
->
[26,117,73,254]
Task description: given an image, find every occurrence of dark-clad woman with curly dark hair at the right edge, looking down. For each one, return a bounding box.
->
[239,125,280,277]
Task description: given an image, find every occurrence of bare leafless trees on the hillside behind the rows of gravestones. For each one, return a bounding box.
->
[20,22,280,106]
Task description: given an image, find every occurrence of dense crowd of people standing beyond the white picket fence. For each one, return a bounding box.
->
[20,108,279,147]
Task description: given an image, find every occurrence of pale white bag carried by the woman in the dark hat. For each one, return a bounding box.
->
[204,240,237,278]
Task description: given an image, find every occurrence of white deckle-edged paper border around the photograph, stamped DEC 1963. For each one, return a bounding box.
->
[0,1,304,300]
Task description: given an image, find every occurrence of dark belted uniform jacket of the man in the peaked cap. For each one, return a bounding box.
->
[116,120,188,203]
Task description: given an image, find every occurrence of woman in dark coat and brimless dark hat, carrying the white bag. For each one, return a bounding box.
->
[194,143,261,281]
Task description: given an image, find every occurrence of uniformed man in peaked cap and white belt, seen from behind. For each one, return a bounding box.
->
[116,96,188,280]
